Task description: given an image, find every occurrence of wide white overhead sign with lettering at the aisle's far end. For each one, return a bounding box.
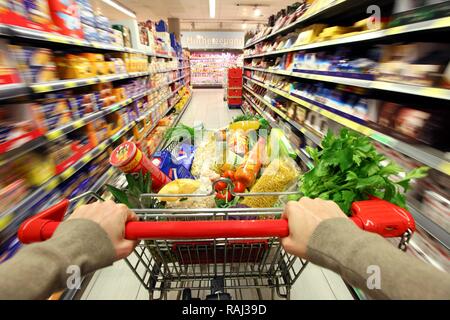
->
[181,31,245,49]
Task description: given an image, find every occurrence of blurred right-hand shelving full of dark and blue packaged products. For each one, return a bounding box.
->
[243,0,450,288]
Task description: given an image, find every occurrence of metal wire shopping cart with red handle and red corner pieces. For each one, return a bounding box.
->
[19,178,414,300]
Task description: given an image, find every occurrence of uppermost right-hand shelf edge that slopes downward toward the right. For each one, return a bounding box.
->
[244,67,450,100]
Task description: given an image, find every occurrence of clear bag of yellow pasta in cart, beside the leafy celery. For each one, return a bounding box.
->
[242,157,301,208]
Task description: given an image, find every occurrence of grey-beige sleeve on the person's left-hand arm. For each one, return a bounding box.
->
[0,219,115,299]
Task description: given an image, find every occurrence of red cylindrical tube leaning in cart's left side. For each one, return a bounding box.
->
[109,141,171,191]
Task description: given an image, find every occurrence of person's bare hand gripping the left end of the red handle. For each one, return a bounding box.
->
[69,200,138,260]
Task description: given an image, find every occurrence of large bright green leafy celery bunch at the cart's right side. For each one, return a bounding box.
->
[300,129,429,214]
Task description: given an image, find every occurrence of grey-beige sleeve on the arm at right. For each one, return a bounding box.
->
[307,218,450,299]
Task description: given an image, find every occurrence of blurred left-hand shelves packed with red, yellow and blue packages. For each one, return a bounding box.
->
[0,0,192,270]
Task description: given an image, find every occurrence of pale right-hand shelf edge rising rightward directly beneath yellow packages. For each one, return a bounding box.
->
[244,17,450,59]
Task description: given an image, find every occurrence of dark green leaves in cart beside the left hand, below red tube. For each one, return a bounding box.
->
[106,172,164,209]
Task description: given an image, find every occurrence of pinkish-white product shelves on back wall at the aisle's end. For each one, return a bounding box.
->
[190,51,244,88]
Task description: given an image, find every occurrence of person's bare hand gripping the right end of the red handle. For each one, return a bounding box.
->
[281,197,347,258]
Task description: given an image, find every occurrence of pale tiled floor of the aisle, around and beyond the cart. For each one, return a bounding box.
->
[81,89,352,300]
